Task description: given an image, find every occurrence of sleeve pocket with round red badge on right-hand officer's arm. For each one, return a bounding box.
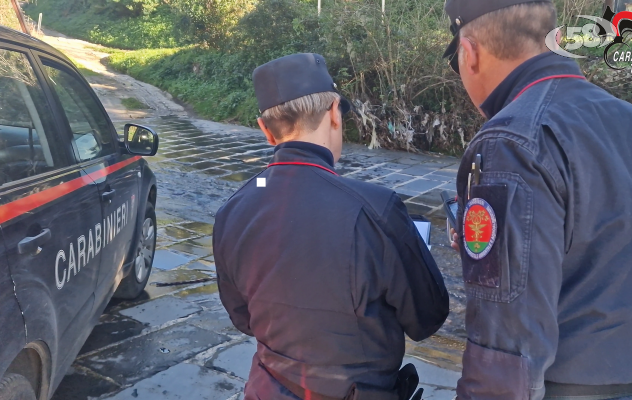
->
[460,172,533,303]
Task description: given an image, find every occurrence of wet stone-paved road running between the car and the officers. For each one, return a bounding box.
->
[40,28,465,400]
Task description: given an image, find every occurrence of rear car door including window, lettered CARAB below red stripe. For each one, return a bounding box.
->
[0,43,104,373]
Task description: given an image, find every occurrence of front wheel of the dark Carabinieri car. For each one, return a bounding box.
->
[112,202,156,300]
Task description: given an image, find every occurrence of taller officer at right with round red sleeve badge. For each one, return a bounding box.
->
[446,0,632,400]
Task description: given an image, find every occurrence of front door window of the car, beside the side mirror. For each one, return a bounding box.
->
[43,60,116,161]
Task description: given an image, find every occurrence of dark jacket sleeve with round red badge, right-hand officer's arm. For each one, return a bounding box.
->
[457,135,566,400]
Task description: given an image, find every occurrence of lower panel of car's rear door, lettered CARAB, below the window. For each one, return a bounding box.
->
[2,166,104,390]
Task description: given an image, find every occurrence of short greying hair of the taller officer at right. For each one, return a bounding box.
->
[461,2,557,60]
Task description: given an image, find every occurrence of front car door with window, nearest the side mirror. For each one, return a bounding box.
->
[40,55,140,307]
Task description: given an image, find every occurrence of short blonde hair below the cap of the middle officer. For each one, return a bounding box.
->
[261,92,340,139]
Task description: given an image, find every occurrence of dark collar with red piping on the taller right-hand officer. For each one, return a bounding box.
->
[480,51,582,119]
